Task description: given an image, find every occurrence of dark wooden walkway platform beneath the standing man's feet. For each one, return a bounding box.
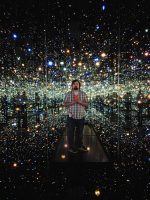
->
[55,125,109,162]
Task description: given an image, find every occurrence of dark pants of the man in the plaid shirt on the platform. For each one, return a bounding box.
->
[67,117,84,148]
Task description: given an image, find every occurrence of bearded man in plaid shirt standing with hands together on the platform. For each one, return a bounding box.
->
[64,80,88,153]
